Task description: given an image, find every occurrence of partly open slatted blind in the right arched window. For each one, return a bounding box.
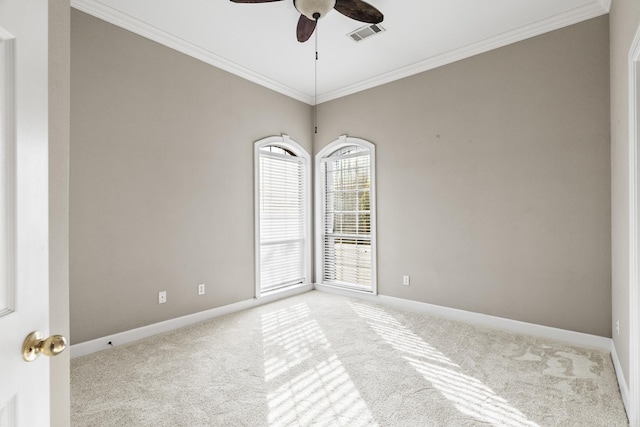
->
[322,147,373,290]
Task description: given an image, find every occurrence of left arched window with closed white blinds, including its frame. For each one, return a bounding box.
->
[255,135,311,297]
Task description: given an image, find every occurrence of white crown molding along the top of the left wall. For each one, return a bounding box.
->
[71,0,314,105]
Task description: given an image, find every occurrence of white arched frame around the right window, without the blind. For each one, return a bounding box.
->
[314,135,378,295]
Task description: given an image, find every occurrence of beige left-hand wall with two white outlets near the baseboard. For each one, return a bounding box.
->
[70,10,312,343]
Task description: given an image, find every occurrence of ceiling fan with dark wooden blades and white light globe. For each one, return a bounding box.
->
[231,0,384,43]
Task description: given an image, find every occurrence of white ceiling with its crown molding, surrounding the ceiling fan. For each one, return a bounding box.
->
[71,0,611,104]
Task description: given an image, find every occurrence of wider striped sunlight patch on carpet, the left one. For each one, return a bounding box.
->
[261,303,376,426]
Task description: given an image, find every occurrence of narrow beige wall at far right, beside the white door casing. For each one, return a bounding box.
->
[610,0,640,388]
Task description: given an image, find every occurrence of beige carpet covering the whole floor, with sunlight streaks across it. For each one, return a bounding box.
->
[71,292,628,427]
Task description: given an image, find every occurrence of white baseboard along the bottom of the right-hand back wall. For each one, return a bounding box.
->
[315,284,611,352]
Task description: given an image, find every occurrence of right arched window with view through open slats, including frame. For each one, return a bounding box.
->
[316,135,377,293]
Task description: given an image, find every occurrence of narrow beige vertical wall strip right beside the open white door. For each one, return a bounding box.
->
[49,0,71,427]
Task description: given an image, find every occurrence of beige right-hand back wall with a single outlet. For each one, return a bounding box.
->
[314,16,611,336]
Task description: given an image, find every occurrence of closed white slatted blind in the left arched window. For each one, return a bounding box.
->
[258,150,306,292]
